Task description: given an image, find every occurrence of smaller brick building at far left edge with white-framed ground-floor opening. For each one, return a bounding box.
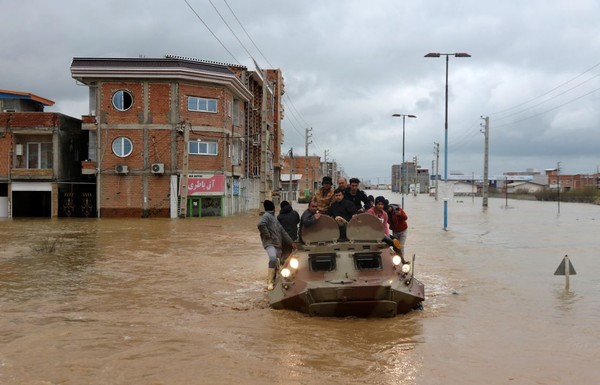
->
[0,90,89,217]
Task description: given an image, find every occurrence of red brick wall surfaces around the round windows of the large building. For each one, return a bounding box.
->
[98,81,242,217]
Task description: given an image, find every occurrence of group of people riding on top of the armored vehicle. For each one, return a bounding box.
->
[257,176,408,290]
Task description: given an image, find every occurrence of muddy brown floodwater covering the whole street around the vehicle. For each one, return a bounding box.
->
[0,192,600,385]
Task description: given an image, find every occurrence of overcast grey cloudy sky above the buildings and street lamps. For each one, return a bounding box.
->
[0,0,600,182]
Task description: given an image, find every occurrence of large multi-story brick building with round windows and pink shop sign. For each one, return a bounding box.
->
[71,57,283,217]
